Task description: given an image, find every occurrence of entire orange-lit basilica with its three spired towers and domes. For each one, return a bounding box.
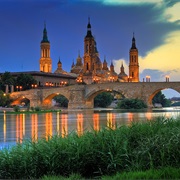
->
[39,19,139,84]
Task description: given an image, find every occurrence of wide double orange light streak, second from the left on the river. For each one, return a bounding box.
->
[16,114,25,143]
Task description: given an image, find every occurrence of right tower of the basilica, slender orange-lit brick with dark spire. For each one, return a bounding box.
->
[129,33,139,82]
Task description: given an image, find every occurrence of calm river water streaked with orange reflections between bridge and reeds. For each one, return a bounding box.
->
[0,107,180,149]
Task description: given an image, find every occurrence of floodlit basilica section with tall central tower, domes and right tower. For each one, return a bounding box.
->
[71,19,139,84]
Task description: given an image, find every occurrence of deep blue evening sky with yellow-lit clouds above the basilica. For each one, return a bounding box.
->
[0,0,180,97]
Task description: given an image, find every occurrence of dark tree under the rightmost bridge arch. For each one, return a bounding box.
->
[152,91,171,107]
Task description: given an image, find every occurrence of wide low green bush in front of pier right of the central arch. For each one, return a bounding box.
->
[116,98,147,109]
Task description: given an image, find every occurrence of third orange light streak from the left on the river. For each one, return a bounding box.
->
[31,114,38,141]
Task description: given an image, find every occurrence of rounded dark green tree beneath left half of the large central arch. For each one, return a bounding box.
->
[94,92,114,108]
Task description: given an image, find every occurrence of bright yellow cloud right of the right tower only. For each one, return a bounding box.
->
[139,31,180,79]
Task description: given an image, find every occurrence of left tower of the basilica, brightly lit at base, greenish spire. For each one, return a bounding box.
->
[39,24,52,73]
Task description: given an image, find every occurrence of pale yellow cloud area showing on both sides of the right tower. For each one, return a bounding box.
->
[113,31,180,81]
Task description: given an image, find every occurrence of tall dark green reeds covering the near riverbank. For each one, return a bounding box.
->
[0,117,180,179]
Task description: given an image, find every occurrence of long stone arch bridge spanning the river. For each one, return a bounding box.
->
[10,82,180,109]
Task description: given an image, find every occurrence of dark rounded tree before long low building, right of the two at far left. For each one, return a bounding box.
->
[15,73,37,90]
